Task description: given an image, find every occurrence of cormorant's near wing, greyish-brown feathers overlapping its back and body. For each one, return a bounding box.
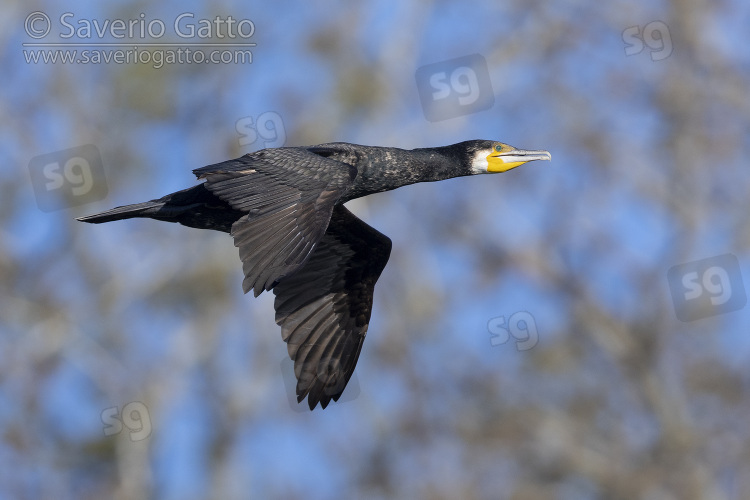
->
[193,148,357,297]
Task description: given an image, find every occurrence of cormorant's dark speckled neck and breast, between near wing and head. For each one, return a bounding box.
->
[347,147,472,199]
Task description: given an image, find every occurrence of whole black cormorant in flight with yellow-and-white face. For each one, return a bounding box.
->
[78,140,551,410]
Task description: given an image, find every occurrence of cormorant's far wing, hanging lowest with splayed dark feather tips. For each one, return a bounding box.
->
[273,206,391,410]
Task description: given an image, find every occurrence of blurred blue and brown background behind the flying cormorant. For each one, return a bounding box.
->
[0,0,750,500]
